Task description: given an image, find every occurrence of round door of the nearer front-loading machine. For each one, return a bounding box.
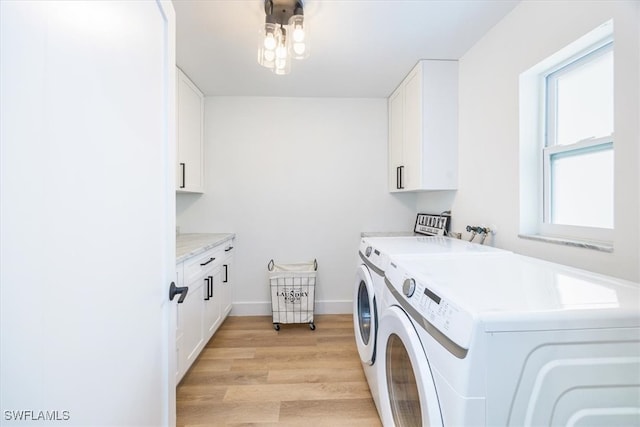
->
[376,306,442,427]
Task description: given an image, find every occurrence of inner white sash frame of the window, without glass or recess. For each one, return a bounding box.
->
[539,37,614,246]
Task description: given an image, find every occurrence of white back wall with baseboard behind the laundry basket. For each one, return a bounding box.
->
[177,97,416,314]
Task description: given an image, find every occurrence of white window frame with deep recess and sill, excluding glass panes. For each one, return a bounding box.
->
[518,20,615,252]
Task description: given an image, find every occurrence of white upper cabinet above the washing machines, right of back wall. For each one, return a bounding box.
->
[388,60,458,192]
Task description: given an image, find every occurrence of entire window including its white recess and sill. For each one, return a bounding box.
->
[520,21,614,251]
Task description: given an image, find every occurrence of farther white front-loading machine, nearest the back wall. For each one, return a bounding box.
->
[353,236,505,420]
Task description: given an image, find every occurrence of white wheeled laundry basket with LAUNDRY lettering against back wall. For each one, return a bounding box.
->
[267,260,318,331]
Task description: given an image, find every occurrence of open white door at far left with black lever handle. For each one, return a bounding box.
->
[0,1,175,426]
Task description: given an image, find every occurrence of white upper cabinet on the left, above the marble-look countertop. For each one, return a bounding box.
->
[176,69,204,193]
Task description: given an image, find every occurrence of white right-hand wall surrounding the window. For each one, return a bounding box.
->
[424,1,640,281]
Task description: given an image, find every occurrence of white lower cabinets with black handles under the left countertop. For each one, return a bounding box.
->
[176,240,233,384]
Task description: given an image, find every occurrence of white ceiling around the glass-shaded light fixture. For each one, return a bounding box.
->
[173,0,519,98]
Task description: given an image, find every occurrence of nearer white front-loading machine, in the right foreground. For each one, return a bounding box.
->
[376,253,640,427]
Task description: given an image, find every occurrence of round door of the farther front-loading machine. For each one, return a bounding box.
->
[353,265,378,365]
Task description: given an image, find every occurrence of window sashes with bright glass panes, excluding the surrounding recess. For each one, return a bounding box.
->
[542,42,613,229]
